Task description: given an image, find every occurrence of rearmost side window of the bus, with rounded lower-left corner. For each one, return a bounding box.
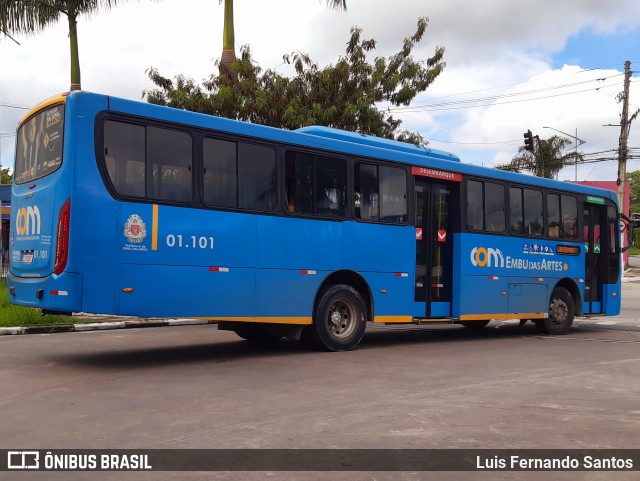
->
[104,120,146,198]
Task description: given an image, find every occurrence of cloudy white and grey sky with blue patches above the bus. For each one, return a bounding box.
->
[0,0,640,180]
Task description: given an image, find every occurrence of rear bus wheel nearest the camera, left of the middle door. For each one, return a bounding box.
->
[309,284,367,351]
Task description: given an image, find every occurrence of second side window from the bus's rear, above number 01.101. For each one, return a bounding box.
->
[147,127,193,202]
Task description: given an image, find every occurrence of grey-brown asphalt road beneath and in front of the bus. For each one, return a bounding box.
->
[0,306,640,480]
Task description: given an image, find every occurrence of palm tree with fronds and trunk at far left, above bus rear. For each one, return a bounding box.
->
[0,0,127,90]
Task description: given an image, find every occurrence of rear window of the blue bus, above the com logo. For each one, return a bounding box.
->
[15,104,64,184]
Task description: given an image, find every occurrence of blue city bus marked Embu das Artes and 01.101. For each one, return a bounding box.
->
[7,91,621,351]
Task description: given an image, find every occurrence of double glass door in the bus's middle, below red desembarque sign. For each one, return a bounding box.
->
[414,177,457,318]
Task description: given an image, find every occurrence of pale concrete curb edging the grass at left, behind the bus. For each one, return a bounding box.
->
[0,319,216,336]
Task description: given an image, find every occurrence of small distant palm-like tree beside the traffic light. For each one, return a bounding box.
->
[496,135,583,179]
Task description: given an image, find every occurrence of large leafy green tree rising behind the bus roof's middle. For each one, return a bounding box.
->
[143,18,445,143]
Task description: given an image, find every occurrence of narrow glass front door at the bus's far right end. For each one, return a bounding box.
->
[584,202,609,314]
